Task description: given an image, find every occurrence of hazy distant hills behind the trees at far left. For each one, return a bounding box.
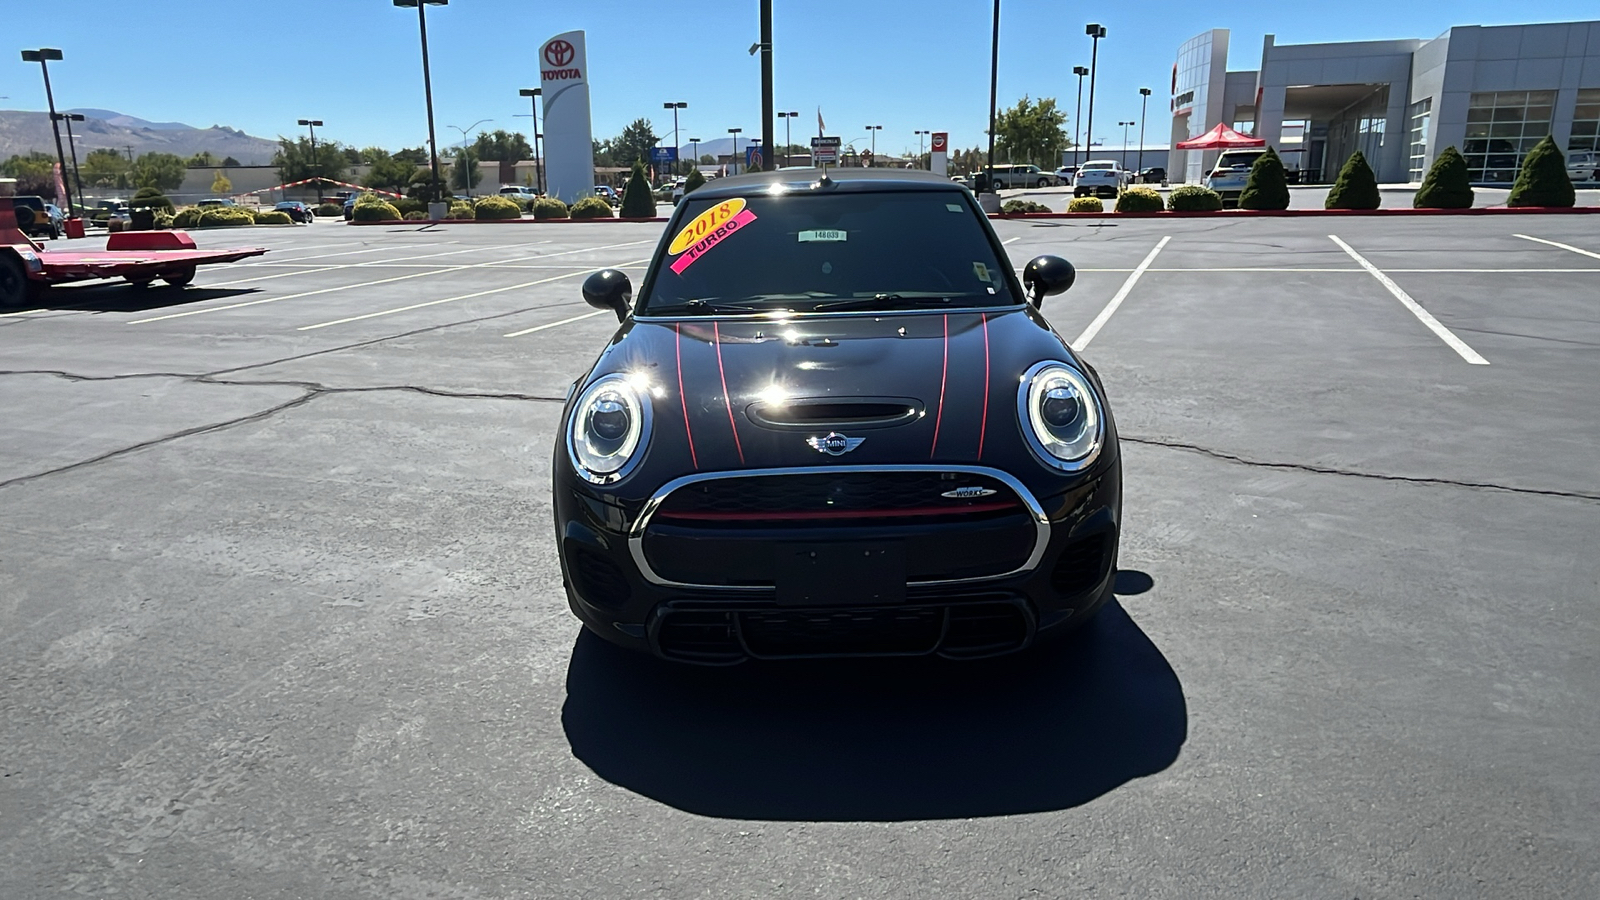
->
[0,109,278,165]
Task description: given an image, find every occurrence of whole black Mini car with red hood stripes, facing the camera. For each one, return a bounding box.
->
[552,170,1122,665]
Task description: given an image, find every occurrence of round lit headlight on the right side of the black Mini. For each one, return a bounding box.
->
[1016,362,1106,472]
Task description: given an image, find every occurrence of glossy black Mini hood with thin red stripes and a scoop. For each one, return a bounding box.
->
[589,307,1100,474]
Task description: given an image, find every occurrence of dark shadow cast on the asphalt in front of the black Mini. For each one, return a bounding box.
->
[562,573,1189,822]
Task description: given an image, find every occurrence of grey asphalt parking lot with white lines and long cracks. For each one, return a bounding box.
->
[0,209,1600,900]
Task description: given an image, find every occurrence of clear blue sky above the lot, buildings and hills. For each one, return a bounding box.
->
[0,0,1600,152]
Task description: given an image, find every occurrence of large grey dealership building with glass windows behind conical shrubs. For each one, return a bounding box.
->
[1166,22,1600,184]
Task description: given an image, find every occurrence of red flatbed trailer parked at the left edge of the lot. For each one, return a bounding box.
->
[0,197,267,309]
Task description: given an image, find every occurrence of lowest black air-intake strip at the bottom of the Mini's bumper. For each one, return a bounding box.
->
[654,594,1034,663]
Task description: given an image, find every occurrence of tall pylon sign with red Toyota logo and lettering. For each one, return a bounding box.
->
[539,32,595,203]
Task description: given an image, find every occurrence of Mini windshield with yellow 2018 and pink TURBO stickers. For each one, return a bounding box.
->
[638,189,1019,315]
